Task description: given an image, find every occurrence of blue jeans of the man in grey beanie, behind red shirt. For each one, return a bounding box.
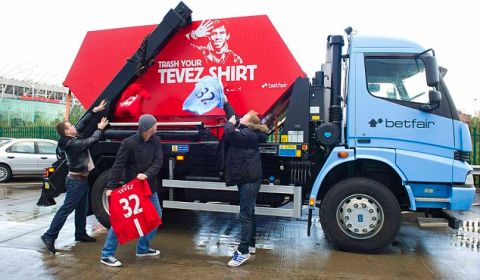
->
[102,193,162,258]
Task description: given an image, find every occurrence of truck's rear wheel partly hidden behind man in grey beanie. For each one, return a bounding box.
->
[90,170,110,228]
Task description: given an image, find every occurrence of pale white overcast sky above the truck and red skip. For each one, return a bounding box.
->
[0,0,480,114]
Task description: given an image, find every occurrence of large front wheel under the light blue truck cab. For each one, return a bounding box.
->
[320,177,401,253]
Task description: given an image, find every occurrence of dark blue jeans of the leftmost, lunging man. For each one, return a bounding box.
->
[44,177,90,241]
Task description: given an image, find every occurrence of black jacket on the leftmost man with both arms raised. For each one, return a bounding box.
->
[58,113,102,173]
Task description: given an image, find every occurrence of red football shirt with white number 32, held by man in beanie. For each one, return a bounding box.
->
[109,179,162,244]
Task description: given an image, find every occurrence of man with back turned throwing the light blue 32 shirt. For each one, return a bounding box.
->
[223,98,269,267]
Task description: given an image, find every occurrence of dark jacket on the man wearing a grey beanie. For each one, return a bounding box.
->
[107,133,163,193]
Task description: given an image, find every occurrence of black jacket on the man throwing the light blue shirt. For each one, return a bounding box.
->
[223,103,267,186]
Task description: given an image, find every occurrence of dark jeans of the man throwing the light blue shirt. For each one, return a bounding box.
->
[238,182,260,254]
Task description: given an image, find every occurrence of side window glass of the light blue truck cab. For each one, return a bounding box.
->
[365,57,429,104]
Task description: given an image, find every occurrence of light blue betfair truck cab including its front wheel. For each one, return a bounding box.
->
[310,34,475,251]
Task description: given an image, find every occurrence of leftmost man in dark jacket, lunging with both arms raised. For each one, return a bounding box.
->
[41,100,108,254]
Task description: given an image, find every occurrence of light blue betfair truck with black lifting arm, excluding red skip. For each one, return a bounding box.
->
[38,3,475,252]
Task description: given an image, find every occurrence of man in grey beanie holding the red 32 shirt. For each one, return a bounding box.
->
[100,114,163,267]
